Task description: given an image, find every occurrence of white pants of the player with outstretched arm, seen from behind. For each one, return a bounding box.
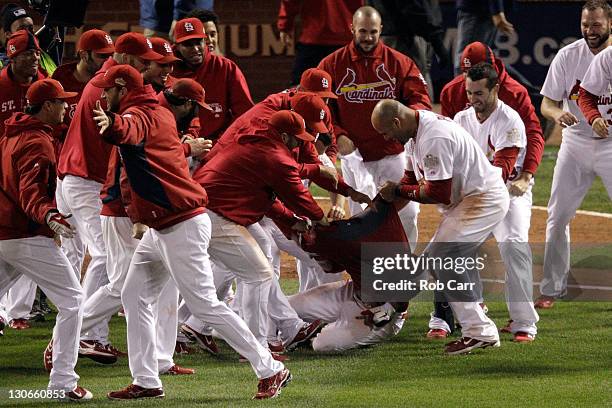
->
[121,213,283,388]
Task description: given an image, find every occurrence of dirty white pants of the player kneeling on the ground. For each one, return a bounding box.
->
[289,281,404,352]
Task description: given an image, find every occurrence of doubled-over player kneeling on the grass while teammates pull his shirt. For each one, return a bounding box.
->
[289,199,410,352]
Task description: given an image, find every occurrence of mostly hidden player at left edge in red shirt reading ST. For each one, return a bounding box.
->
[0,29,47,330]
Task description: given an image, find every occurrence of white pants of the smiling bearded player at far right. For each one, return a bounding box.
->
[540,138,612,297]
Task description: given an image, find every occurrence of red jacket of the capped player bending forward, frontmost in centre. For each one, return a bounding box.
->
[193,133,324,226]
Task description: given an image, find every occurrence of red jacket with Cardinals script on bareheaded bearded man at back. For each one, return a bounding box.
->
[318,41,431,161]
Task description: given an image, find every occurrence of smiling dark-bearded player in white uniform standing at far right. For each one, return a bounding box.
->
[535,1,612,309]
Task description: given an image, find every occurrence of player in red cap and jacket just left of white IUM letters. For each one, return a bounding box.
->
[173,18,253,140]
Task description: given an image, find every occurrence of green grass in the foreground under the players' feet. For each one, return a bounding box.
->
[0,279,612,408]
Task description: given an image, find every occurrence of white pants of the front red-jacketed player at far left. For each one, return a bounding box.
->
[0,236,83,391]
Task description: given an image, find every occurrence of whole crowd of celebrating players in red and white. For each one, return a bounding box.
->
[0,0,612,400]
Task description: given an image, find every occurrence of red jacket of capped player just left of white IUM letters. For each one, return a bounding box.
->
[172,47,253,140]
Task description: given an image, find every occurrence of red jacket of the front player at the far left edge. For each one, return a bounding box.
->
[0,113,57,240]
